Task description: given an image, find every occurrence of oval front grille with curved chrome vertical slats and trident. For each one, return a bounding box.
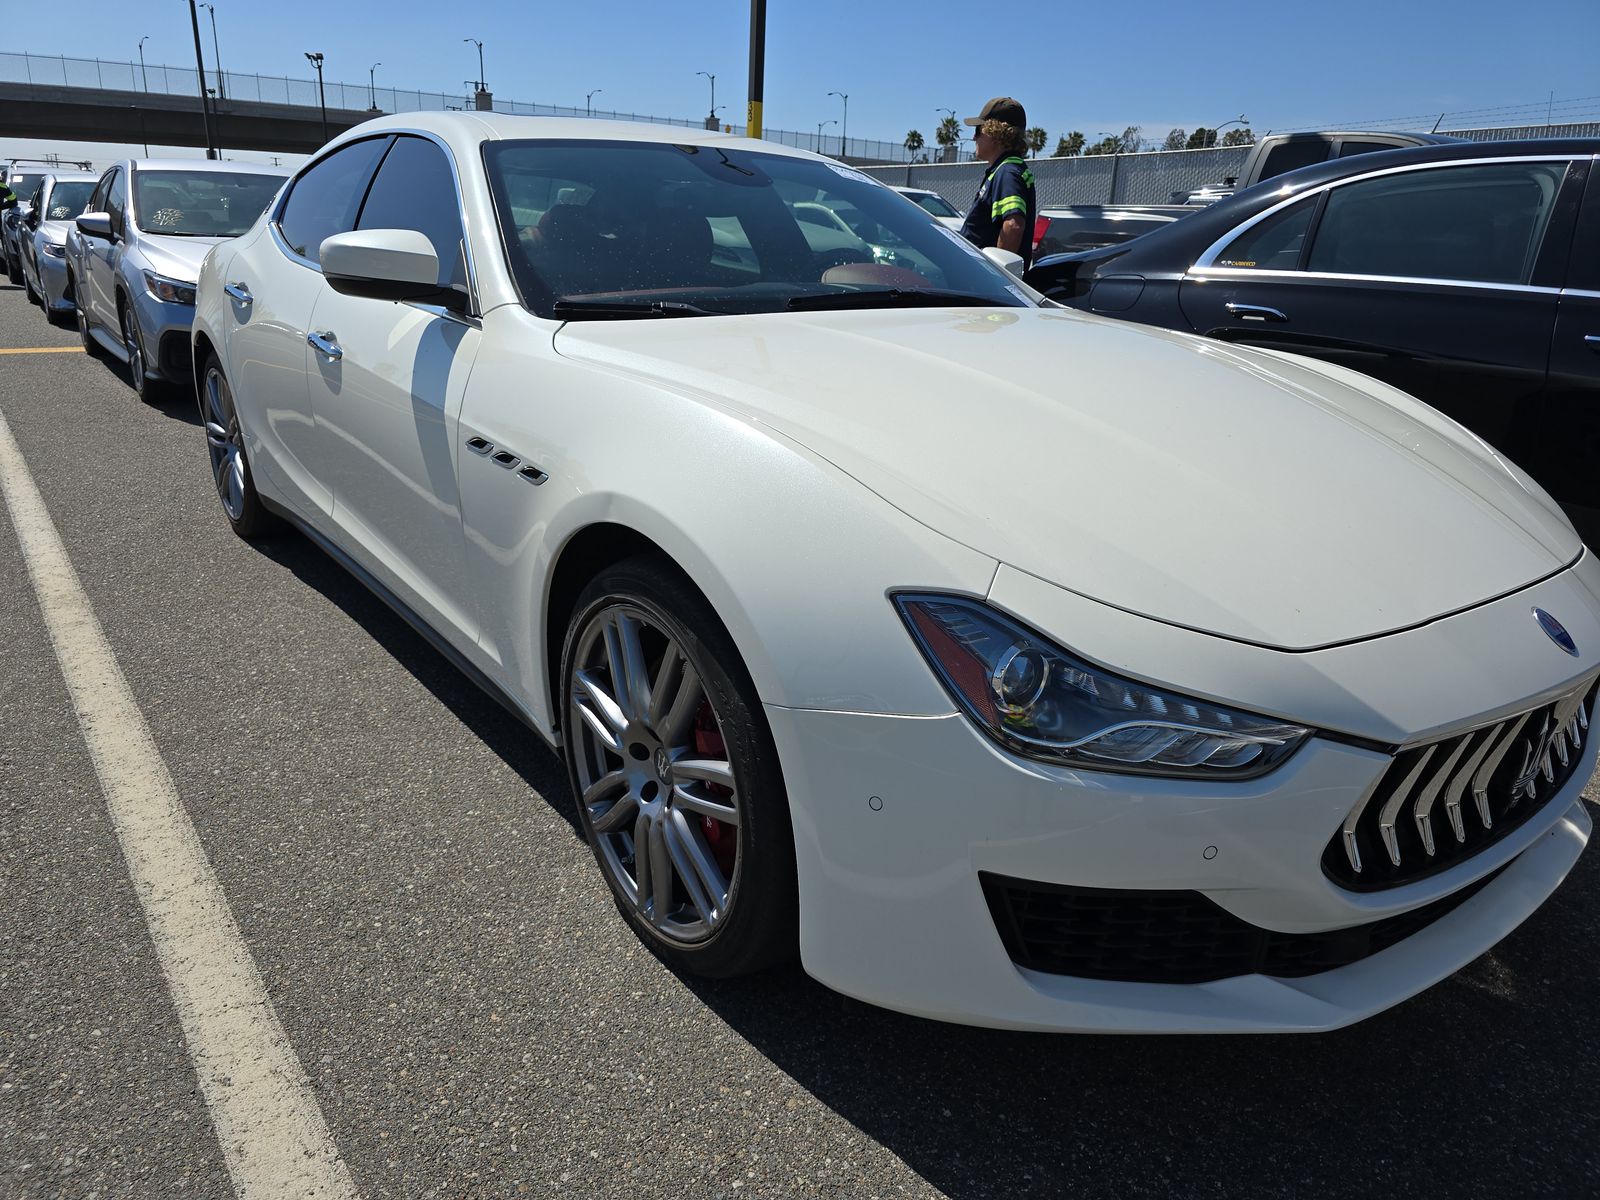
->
[1322,680,1597,891]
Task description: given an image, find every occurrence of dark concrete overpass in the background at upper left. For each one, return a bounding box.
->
[0,82,378,154]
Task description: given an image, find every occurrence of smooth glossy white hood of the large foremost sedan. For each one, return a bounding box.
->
[555,309,1581,650]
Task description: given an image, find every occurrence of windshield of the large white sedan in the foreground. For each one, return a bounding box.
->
[483,141,1030,318]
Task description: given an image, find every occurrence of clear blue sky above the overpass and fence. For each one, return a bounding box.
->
[0,0,1600,167]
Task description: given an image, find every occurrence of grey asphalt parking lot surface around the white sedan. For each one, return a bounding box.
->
[0,272,1600,1200]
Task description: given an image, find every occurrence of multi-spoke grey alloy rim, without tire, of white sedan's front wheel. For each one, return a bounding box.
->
[566,602,742,946]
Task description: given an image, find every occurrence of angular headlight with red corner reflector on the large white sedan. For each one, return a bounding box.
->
[894,595,1310,779]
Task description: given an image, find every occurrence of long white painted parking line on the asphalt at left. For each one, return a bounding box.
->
[0,414,355,1200]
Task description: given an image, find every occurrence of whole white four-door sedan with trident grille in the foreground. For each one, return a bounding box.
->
[194,114,1600,1032]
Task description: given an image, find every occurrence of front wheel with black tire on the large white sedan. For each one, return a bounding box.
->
[562,555,798,978]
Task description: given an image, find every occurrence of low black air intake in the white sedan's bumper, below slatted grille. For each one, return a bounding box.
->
[978,870,1499,984]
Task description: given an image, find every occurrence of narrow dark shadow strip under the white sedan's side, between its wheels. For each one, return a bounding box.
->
[244,531,582,838]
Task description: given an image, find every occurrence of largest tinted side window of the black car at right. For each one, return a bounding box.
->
[1307,162,1566,283]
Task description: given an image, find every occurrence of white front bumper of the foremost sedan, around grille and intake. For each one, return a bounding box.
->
[766,560,1600,1032]
